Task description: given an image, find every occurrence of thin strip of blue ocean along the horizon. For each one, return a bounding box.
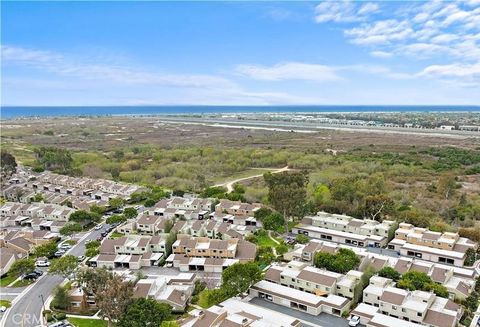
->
[0,105,480,119]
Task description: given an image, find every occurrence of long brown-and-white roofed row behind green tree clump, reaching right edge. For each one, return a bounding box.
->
[284,240,477,300]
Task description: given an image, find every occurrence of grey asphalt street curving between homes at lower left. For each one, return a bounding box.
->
[0,225,108,327]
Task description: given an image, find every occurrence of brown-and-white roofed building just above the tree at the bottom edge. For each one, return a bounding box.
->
[133,273,195,312]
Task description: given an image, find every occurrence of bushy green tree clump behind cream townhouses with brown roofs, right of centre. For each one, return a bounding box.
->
[313,249,360,274]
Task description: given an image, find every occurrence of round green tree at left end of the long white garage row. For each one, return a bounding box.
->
[222,262,262,296]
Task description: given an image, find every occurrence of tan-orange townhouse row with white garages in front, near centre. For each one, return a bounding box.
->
[167,235,257,272]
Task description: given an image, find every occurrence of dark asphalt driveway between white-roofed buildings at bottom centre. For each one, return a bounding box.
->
[250,298,348,327]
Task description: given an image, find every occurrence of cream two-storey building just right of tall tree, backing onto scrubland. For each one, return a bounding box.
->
[303,211,395,237]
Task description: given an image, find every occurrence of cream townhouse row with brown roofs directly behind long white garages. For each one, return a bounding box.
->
[265,261,362,299]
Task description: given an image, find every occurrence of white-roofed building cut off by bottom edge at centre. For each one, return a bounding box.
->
[181,298,302,327]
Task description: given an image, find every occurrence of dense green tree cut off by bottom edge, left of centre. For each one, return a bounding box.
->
[116,298,172,327]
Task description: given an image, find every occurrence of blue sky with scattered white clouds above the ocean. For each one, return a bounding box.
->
[1,0,480,106]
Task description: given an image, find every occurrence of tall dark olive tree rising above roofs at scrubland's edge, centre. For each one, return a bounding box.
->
[263,172,308,233]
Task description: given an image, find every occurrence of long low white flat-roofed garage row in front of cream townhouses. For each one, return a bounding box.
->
[249,280,351,316]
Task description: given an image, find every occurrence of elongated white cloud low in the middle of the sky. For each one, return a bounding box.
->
[235,62,340,82]
